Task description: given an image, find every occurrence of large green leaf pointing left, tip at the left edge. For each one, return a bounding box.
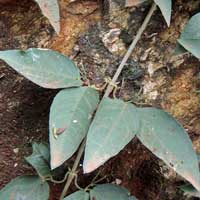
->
[0,48,82,89]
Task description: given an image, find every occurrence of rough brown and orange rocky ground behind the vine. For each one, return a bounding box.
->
[0,0,200,200]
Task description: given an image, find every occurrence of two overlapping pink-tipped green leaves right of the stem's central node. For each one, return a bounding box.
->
[83,98,200,191]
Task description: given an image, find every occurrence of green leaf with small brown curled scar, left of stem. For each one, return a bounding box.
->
[49,87,99,169]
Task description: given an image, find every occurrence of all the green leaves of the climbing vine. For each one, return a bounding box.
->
[0,0,200,200]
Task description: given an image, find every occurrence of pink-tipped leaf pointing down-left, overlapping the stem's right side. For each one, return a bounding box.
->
[83,98,139,173]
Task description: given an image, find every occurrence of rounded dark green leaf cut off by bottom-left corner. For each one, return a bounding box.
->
[0,176,49,200]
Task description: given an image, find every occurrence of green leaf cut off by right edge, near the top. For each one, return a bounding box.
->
[178,13,200,58]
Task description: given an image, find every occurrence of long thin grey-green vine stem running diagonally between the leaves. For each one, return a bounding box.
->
[60,3,156,200]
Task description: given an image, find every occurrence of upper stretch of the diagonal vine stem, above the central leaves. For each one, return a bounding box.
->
[104,3,156,97]
